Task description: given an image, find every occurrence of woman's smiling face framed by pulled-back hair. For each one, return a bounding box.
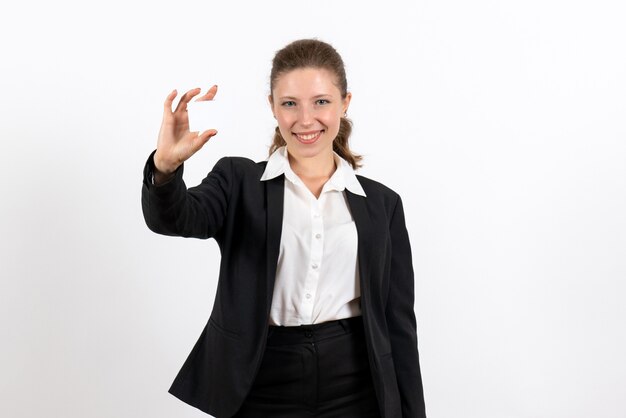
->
[269,67,351,165]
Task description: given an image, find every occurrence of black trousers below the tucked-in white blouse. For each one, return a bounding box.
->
[233,316,380,418]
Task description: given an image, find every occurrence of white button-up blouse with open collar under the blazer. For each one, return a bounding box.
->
[261,146,365,326]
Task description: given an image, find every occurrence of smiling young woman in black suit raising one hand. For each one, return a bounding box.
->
[142,40,426,418]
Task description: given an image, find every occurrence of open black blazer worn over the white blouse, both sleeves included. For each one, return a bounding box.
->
[141,153,426,418]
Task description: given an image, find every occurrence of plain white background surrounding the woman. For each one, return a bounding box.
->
[0,0,626,418]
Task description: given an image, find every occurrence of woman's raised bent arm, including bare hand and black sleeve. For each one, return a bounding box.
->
[141,86,231,238]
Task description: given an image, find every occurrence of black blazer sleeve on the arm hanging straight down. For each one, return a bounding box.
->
[386,196,426,418]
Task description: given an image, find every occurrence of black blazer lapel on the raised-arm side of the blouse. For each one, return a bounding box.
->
[265,175,285,310]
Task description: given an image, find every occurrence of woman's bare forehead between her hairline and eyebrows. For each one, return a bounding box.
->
[273,67,340,97]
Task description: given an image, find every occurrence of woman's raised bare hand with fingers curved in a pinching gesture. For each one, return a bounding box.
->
[154,86,217,176]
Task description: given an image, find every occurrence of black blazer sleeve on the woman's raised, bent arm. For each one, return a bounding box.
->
[141,152,232,238]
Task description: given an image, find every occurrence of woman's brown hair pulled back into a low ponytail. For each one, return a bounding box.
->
[269,39,363,169]
